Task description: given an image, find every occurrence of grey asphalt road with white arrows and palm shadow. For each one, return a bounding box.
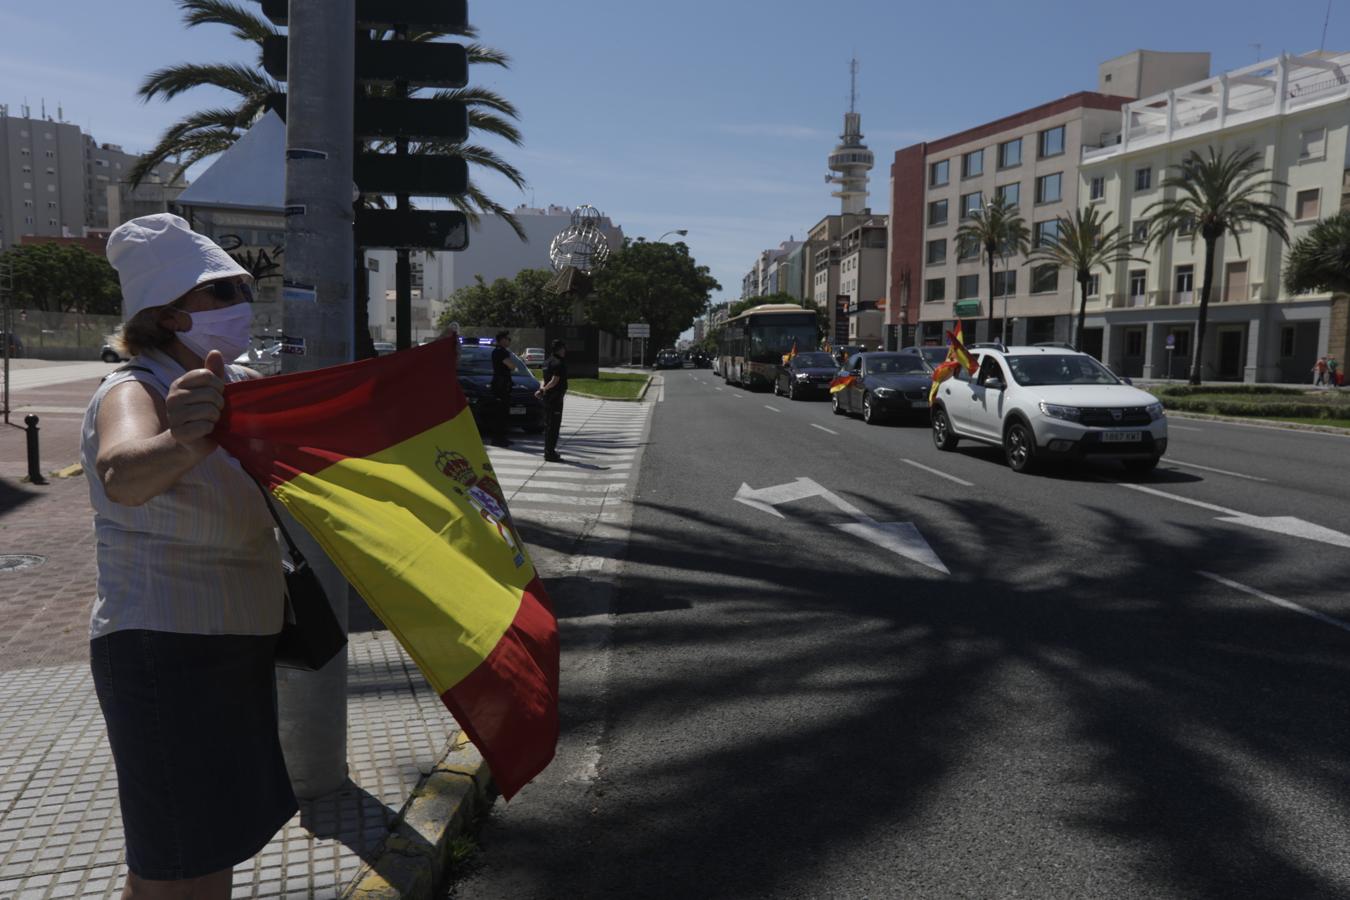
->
[451,371,1350,900]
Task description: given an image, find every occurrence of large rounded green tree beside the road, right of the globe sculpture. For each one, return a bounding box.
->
[586,237,722,347]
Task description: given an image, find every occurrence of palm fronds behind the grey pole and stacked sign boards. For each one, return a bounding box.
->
[128,0,525,240]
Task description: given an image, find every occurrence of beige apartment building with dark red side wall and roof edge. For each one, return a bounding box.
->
[884,51,1210,344]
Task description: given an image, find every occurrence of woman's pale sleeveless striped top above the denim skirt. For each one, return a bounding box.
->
[80,351,285,640]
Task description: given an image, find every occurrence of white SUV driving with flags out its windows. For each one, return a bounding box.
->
[933,347,1168,472]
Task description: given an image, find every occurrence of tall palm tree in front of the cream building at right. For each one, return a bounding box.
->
[1143,147,1289,385]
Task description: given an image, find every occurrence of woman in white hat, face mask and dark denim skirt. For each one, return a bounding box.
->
[81,213,297,900]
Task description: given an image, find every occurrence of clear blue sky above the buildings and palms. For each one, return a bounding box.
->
[0,0,1350,306]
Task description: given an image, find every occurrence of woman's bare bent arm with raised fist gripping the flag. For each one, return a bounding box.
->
[95,351,224,506]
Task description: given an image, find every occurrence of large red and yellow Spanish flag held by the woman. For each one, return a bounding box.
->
[215,340,559,799]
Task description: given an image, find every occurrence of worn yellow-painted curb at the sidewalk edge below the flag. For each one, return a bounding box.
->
[338,731,491,900]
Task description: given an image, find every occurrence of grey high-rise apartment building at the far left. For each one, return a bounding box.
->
[0,104,182,248]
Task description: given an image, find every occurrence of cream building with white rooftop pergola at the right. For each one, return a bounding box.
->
[1079,53,1350,382]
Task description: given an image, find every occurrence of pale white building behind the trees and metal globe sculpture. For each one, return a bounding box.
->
[366,206,624,341]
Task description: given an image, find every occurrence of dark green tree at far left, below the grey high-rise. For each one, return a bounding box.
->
[4,244,122,316]
